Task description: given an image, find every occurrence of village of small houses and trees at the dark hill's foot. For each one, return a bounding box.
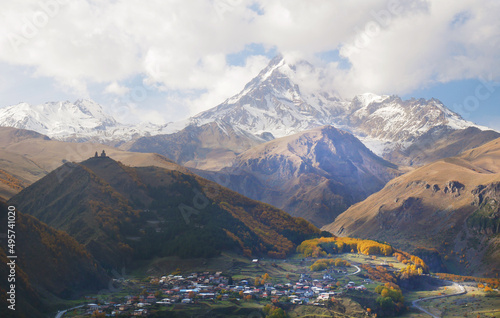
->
[67,260,372,317]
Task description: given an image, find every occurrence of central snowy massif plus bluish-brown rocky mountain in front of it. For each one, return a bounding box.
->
[121,56,500,226]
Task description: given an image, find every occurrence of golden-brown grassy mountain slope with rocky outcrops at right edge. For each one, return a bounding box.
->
[323,139,500,275]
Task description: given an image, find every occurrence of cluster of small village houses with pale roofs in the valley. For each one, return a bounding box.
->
[82,271,370,316]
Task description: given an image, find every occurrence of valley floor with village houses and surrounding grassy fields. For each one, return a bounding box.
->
[56,253,498,318]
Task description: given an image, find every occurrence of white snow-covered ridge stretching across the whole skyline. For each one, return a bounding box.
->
[0,56,488,155]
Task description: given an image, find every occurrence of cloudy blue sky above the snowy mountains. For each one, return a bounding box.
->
[0,0,500,130]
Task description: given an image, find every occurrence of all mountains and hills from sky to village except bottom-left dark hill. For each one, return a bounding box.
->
[0,56,500,275]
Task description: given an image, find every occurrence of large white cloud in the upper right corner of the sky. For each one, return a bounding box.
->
[337,1,500,94]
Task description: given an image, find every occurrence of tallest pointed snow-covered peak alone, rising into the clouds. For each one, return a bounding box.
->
[190,56,344,137]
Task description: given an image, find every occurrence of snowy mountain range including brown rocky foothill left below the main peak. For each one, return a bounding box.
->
[0,55,488,166]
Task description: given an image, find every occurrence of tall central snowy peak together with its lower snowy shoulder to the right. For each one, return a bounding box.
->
[182,55,487,155]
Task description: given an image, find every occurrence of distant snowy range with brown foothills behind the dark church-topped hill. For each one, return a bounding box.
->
[0,56,500,231]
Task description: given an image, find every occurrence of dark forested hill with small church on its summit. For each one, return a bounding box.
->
[9,158,319,268]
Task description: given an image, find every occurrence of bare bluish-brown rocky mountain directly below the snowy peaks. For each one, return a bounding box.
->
[195,126,401,226]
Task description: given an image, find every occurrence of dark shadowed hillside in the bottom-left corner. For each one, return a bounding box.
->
[0,202,109,317]
